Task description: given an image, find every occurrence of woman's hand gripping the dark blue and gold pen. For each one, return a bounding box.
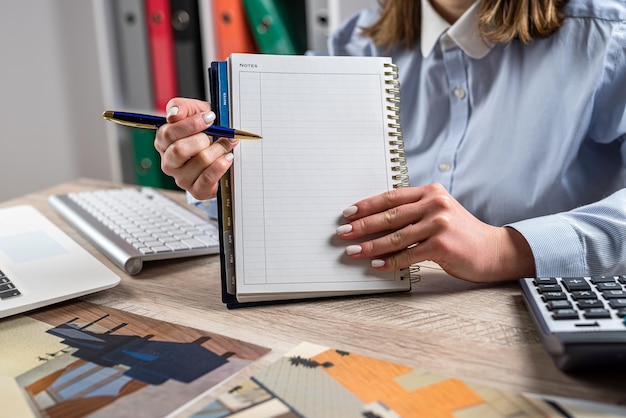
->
[154,97,239,200]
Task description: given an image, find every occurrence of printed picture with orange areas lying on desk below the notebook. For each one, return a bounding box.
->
[191,342,626,418]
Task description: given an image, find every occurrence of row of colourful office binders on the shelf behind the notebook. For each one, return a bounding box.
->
[96,0,376,188]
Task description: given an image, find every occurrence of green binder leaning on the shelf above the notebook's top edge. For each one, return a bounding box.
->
[243,0,307,55]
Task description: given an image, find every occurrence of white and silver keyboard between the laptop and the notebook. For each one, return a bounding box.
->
[49,187,219,275]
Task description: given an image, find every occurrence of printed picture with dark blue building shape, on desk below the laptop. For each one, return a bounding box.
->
[0,302,269,418]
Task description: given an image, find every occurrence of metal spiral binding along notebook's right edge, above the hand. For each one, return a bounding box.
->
[385,63,409,188]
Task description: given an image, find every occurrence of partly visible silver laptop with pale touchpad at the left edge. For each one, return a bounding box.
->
[0,205,120,318]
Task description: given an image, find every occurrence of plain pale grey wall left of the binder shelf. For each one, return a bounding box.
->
[0,0,113,201]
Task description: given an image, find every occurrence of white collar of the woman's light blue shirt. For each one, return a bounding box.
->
[420,0,493,59]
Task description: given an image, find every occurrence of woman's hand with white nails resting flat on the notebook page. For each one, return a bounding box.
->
[337,184,535,282]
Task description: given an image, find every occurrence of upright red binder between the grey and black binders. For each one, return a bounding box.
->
[145,0,178,112]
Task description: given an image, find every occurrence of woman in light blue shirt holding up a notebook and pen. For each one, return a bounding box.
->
[155,0,626,282]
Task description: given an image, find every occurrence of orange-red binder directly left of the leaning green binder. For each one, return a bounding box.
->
[213,0,258,60]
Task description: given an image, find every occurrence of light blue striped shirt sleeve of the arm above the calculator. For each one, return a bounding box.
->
[508,22,626,277]
